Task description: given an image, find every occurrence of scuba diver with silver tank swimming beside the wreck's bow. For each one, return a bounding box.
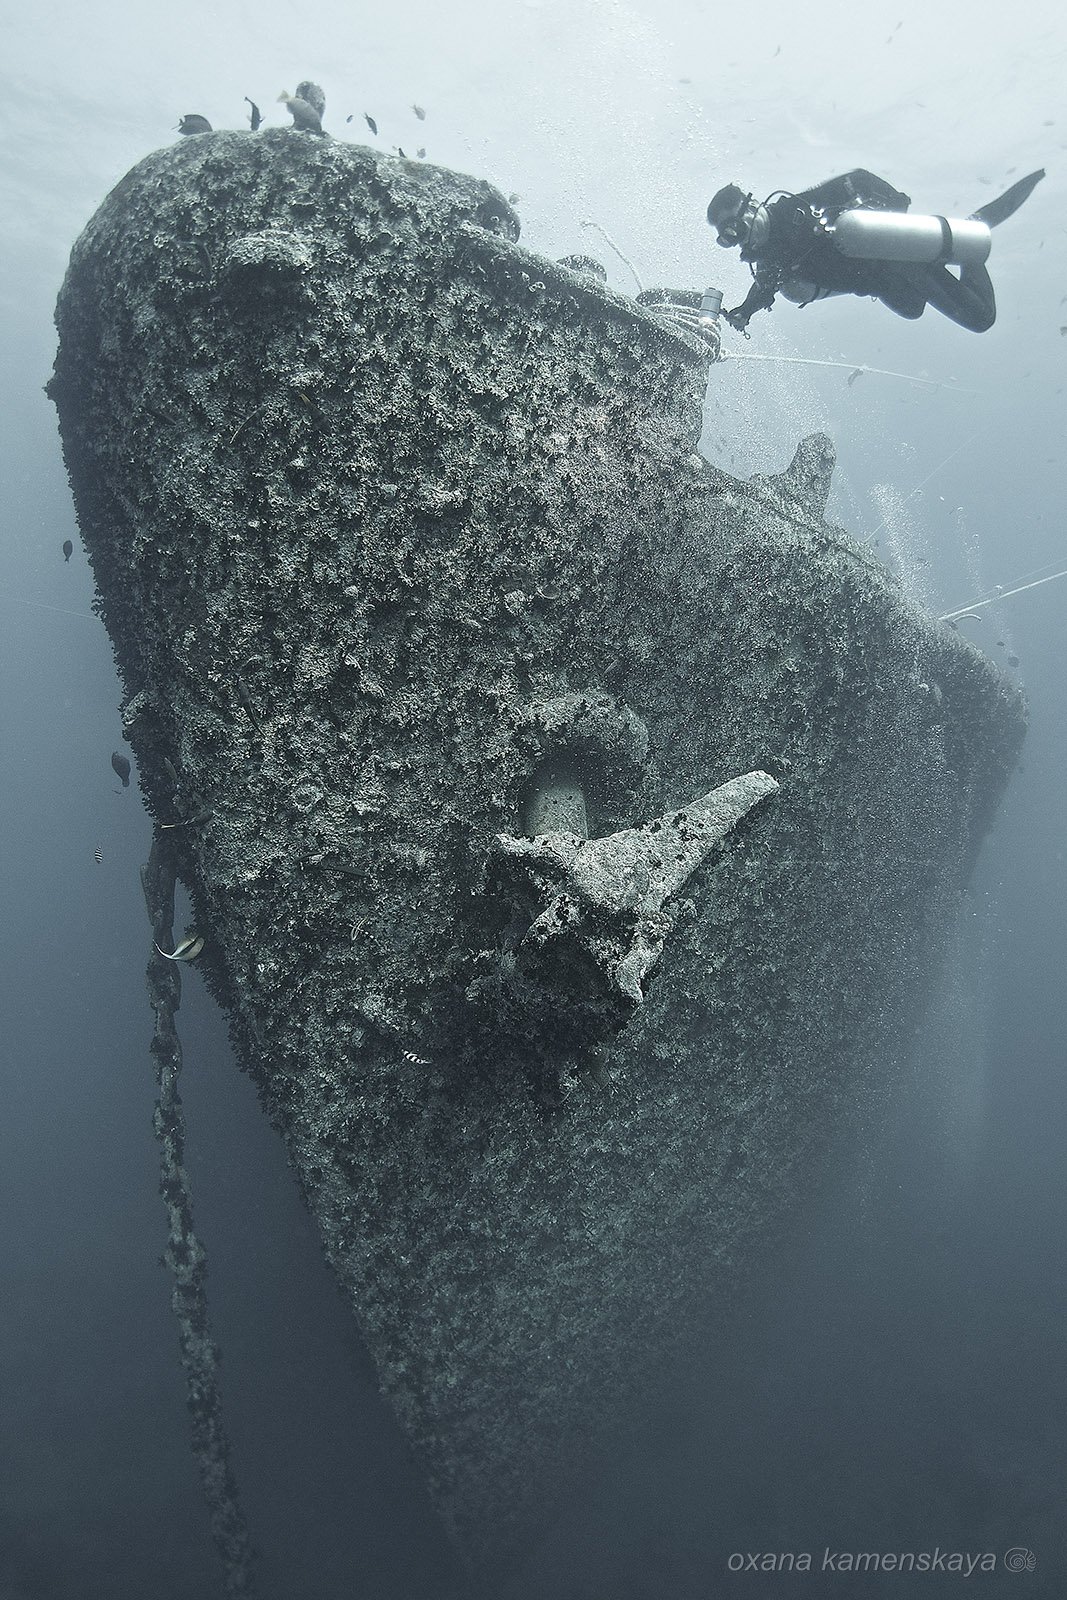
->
[707,166,1045,336]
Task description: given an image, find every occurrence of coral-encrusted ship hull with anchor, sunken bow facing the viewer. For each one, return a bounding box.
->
[51,130,1024,1570]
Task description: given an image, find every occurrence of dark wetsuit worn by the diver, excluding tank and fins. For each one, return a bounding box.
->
[726,166,997,333]
